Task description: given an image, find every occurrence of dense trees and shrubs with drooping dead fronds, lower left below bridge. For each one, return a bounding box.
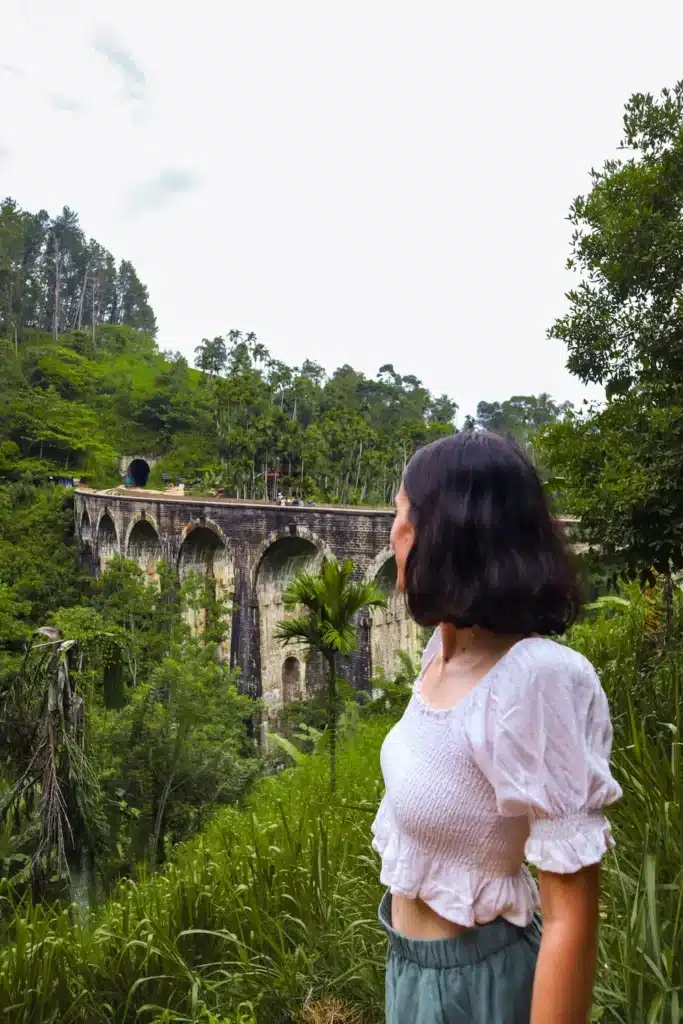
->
[0,528,263,897]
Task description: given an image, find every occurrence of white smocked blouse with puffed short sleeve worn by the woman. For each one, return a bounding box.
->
[372,629,622,927]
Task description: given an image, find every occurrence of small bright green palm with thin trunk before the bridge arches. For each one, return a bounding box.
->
[275,558,386,793]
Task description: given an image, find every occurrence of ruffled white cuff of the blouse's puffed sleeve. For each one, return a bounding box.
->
[524,814,614,874]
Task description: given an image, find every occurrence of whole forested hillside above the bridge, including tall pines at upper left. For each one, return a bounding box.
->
[0,200,569,505]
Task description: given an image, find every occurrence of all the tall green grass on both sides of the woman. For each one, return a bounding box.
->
[0,594,683,1024]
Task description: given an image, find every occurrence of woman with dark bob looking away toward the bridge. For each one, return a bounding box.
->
[373,432,621,1024]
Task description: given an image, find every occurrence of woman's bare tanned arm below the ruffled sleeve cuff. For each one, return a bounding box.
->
[530,864,600,1024]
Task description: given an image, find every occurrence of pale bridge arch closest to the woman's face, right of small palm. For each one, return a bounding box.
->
[365,548,421,679]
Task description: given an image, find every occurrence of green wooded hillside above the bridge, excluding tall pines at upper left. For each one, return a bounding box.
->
[0,325,464,502]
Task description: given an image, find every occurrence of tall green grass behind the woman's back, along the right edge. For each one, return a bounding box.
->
[570,590,683,1024]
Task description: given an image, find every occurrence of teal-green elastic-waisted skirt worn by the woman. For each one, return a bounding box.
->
[380,893,541,1024]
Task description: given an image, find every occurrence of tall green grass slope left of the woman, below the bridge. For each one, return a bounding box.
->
[0,721,387,1024]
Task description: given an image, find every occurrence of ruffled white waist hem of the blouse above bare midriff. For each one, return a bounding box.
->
[373,809,539,928]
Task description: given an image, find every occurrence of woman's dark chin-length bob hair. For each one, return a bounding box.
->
[403,430,581,636]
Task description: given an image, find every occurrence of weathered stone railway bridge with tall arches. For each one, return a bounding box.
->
[76,488,420,711]
